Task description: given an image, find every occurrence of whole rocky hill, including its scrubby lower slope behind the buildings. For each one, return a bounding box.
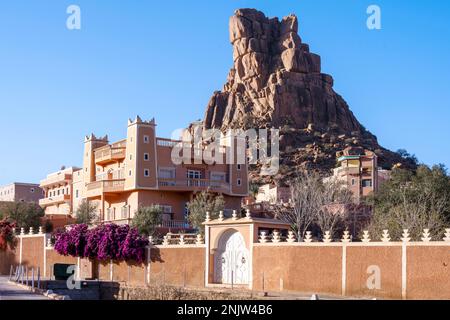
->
[203,9,414,182]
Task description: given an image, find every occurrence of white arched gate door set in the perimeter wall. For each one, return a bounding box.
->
[214,231,250,284]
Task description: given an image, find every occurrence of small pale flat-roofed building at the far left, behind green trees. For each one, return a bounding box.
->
[0,182,44,203]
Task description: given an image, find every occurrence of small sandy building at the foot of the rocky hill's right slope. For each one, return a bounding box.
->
[328,147,390,203]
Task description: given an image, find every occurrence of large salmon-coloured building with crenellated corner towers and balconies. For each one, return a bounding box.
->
[43,117,248,229]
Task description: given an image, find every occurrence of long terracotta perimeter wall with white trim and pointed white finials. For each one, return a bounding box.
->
[0,230,450,299]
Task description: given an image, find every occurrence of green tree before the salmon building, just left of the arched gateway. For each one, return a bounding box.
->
[187,191,225,234]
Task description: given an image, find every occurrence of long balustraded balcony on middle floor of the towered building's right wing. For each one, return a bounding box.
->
[158,179,230,192]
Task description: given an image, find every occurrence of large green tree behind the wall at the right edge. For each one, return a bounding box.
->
[367,165,450,240]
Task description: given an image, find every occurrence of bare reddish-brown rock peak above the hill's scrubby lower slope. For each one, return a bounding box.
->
[204,9,362,132]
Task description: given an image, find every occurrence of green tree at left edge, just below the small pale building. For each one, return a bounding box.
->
[0,201,45,230]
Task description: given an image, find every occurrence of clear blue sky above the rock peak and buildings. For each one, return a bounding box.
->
[0,0,450,185]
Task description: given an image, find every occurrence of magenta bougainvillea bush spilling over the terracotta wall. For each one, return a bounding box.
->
[55,224,148,263]
